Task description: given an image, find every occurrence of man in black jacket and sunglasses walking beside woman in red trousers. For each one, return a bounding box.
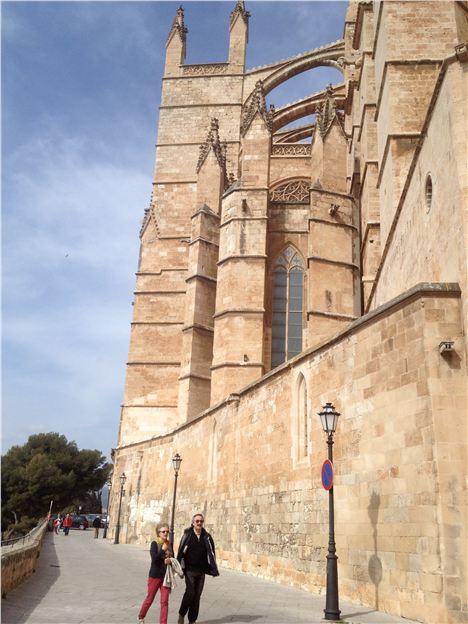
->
[177,513,219,624]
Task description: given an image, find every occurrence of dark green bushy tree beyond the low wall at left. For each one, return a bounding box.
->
[2,433,111,528]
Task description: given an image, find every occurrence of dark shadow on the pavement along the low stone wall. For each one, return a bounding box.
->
[2,533,60,624]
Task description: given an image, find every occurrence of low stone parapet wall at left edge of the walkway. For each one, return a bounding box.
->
[2,520,47,598]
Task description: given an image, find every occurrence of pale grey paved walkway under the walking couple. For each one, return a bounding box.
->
[2,530,418,624]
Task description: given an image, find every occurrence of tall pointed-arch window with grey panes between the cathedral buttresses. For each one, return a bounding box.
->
[271,247,304,368]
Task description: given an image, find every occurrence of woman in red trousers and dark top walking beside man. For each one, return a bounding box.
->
[138,524,173,624]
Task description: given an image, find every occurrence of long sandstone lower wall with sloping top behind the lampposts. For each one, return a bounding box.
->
[111,284,467,623]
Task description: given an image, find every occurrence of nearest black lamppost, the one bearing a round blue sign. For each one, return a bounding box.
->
[318,403,341,621]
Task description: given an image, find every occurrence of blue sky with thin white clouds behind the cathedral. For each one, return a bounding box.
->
[2,1,346,455]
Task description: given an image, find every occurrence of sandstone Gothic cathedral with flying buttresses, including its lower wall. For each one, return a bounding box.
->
[108,0,468,624]
